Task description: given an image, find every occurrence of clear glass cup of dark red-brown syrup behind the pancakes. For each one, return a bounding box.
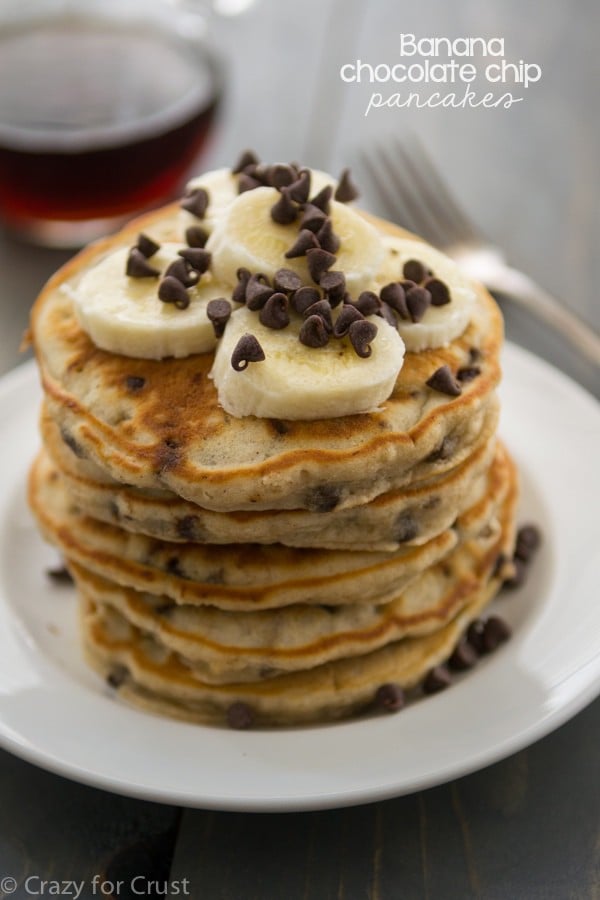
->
[0,4,221,246]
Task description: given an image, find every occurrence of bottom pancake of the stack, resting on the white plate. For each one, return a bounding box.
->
[81,460,517,725]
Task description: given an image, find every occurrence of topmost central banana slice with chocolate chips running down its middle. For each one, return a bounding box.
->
[206,187,385,296]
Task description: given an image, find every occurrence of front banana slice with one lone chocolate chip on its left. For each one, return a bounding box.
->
[211,307,404,419]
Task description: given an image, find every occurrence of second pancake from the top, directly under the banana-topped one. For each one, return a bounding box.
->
[42,409,497,552]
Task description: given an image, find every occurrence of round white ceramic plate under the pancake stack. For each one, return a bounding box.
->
[0,346,600,810]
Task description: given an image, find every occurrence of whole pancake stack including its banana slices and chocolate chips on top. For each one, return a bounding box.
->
[29,151,536,728]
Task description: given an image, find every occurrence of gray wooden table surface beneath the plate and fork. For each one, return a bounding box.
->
[0,0,600,900]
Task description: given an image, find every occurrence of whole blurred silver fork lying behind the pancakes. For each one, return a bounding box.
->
[361,137,600,366]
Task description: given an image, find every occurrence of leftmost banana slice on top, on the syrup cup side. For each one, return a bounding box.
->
[69,243,230,359]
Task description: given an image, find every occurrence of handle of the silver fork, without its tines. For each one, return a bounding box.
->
[485,266,600,367]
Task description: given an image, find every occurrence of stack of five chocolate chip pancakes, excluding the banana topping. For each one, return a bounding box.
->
[29,202,517,725]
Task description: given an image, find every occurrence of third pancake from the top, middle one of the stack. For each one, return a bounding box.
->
[29,446,514,611]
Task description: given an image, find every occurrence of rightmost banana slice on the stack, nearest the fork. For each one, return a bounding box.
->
[375,235,476,353]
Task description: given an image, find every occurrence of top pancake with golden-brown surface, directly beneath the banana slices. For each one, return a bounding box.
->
[31,206,503,511]
